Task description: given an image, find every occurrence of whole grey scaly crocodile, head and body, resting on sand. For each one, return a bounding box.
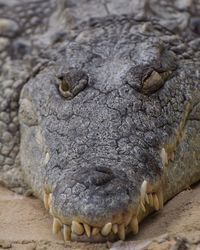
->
[0,0,200,242]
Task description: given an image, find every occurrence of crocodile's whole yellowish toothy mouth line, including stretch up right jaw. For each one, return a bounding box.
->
[40,99,197,242]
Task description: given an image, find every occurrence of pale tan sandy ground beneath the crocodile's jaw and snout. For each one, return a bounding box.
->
[0,183,200,250]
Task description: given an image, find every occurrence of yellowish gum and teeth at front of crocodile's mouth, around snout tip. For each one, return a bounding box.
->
[43,180,163,242]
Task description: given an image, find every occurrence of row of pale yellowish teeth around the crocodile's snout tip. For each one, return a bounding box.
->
[44,184,163,241]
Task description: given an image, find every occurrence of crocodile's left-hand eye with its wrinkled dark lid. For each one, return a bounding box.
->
[58,70,88,99]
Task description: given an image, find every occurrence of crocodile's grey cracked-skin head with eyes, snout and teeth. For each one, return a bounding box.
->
[19,17,200,241]
